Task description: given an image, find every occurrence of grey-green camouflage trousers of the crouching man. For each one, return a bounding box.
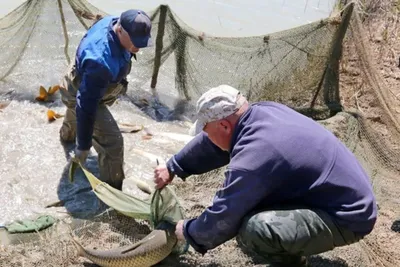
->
[237,207,362,266]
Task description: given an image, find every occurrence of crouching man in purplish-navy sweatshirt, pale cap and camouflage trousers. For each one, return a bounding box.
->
[154,85,377,266]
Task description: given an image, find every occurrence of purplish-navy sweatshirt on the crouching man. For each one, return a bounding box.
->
[167,102,377,253]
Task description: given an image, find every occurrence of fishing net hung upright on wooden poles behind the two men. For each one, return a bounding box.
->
[0,0,352,114]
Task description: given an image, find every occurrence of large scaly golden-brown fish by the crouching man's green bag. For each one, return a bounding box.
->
[70,221,178,267]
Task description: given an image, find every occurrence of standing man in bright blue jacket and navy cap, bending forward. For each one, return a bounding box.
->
[60,9,152,189]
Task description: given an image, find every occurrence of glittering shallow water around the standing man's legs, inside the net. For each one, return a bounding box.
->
[0,95,192,227]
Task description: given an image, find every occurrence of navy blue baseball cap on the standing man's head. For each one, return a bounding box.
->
[120,9,152,48]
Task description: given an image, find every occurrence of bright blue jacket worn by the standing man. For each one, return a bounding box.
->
[76,16,132,150]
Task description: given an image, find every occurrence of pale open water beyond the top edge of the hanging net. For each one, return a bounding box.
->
[0,0,336,36]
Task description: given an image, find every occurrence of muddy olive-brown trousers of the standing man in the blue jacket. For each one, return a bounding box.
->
[60,60,126,189]
